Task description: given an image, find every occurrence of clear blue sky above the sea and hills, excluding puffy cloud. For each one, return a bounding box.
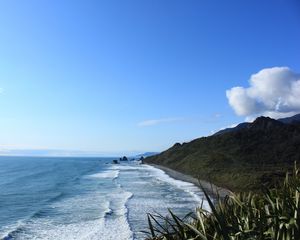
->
[0,0,300,154]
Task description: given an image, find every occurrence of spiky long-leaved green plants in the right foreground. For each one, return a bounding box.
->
[147,166,300,240]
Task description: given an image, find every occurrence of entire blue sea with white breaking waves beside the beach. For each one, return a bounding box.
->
[0,157,207,240]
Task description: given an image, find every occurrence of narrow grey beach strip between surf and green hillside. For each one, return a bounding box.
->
[145,163,232,198]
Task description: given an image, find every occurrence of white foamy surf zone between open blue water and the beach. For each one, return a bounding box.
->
[4,161,209,240]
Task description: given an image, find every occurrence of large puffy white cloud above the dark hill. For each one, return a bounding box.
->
[226,67,300,121]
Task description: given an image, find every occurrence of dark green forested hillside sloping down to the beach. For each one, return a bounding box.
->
[145,114,300,190]
